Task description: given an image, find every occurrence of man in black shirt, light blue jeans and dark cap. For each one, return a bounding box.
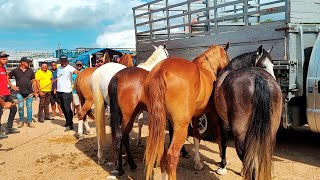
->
[9,57,38,128]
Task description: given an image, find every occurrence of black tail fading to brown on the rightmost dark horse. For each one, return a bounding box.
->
[243,76,273,180]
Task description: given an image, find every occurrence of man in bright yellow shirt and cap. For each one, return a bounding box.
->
[35,63,52,122]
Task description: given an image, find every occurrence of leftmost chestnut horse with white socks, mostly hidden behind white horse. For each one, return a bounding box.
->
[75,53,133,139]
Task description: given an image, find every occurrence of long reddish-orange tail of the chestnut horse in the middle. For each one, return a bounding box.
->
[145,75,166,179]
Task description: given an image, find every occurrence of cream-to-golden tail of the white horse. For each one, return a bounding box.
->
[91,73,106,158]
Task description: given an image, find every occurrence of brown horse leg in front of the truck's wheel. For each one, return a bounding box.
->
[192,118,203,171]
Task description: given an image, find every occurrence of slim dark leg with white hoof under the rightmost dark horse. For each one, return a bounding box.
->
[217,118,228,175]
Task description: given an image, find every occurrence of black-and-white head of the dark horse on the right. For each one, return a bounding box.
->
[255,45,275,78]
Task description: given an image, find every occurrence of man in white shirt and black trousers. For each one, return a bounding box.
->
[57,55,78,131]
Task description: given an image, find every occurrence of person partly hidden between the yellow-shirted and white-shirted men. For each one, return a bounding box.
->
[50,61,63,117]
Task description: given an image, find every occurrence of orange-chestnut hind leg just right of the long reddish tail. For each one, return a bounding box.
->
[167,121,188,180]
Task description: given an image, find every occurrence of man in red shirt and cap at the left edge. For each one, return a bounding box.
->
[0,52,20,139]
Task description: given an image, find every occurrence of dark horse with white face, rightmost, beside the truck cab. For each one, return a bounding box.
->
[214,46,282,180]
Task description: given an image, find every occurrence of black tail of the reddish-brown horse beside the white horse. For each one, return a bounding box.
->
[109,76,122,158]
